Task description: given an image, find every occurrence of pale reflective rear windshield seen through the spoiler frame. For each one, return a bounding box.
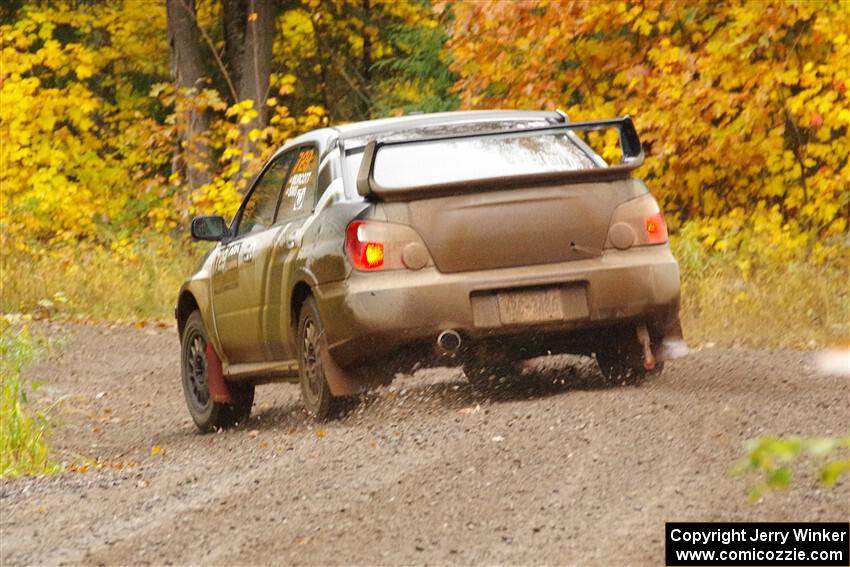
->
[368,130,605,189]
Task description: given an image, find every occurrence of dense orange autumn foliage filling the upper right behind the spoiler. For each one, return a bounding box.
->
[448,0,850,247]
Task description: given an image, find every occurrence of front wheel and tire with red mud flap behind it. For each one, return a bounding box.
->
[180,311,254,433]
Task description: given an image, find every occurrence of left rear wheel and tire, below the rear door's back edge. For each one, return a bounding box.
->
[297,297,348,420]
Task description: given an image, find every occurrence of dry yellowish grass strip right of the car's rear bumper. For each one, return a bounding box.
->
[672,232,850,349]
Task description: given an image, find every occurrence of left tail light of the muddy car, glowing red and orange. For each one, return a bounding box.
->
[345,221,433,271]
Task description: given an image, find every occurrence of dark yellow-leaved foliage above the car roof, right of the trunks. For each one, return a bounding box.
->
[274,0,442,122]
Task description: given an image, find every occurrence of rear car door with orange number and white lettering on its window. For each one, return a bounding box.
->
[263,144,319,361]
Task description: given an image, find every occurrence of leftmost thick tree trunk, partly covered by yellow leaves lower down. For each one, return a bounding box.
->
[166,0,210,189]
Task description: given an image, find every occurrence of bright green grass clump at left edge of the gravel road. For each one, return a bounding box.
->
[0,319,60,476]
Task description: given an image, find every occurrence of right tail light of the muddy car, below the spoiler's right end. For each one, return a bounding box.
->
[605,193,667,250]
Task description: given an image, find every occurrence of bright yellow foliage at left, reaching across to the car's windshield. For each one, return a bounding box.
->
[0,0,332,251]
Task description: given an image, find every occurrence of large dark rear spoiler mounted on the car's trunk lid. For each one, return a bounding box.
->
[357,115,644,201]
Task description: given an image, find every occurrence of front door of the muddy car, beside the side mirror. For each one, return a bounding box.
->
[212,152,296,363]
